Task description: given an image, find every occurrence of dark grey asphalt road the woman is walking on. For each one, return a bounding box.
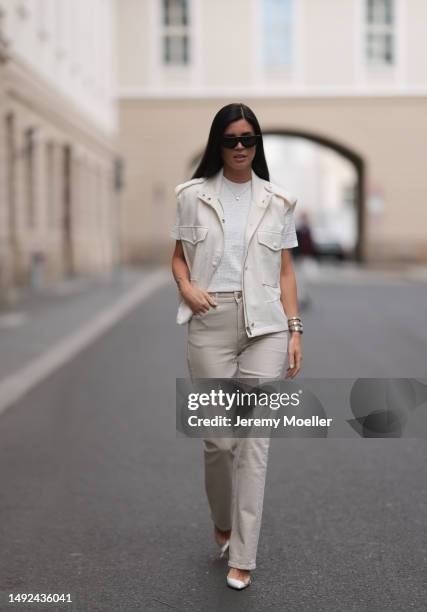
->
[0,274,427,612]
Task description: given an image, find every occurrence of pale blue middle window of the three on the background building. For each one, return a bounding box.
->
[261,0,294,68]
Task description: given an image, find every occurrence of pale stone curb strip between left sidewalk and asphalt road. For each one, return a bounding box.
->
[0,268,171,414]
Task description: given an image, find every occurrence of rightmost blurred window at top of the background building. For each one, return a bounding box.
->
[365,0,395,66]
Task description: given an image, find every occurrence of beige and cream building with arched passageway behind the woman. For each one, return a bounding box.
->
[118,0,427,262]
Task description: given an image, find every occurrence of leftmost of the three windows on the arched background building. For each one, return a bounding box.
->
[162,0,190,66]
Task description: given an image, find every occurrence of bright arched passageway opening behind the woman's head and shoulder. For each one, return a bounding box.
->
[190,129,365,261]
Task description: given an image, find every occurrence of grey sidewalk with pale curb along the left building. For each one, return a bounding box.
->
[0,266,172,413]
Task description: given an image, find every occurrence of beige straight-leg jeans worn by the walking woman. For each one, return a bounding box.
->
[187,291,289,570]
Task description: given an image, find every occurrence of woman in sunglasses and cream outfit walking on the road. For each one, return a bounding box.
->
[171,103,303,589]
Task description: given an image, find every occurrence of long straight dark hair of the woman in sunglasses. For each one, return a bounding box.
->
[191,102,270,181]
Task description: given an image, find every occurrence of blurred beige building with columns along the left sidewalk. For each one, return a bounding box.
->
[0,0,123,303]
